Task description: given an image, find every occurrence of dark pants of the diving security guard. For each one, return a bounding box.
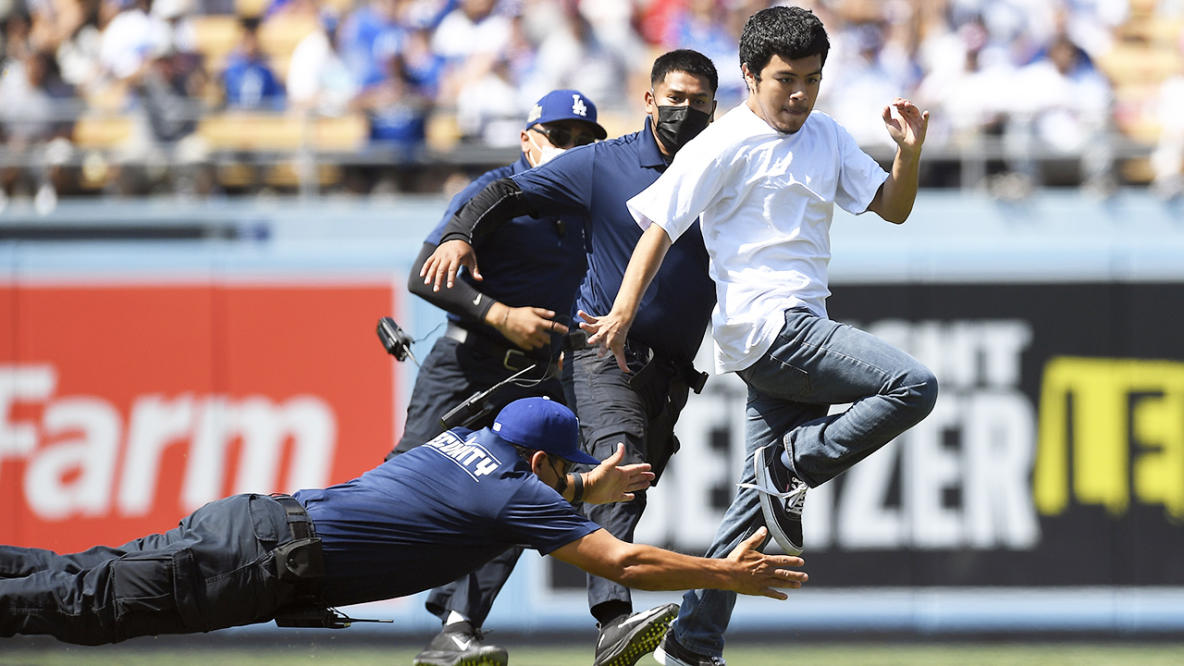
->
[0,494,292,645]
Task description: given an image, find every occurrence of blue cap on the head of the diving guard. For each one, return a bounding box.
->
[493,398,600,465]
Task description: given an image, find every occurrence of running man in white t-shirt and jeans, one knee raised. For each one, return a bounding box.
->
[581,7,938,666]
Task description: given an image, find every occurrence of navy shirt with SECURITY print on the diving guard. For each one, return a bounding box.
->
[295,428,600,606]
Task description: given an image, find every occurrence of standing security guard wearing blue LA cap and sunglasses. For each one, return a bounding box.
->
[387,90,606,665]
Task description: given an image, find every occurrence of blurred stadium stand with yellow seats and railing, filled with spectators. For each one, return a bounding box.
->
[0,0,1184,205]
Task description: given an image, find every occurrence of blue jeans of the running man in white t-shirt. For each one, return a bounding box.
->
[671,308,938,657]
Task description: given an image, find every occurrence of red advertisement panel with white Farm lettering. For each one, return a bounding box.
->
[0,283,395,552]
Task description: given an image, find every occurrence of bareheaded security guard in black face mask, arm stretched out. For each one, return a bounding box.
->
[422,50,719,665]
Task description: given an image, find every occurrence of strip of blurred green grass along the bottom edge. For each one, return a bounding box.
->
[13,641,1184,666]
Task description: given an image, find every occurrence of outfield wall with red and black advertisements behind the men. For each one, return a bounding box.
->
[0,193,1184,633]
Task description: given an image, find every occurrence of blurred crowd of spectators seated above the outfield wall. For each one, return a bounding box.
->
[0,0,1184,206]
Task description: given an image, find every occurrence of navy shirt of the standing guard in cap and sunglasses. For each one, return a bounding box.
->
[425,155,586,343]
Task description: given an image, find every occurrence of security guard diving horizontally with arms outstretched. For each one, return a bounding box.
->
[0,398,806,664]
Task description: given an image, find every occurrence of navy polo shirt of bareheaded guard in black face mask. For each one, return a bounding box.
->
[509,120,715,363]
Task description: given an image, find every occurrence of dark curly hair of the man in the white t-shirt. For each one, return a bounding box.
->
[740,7,830,77]
